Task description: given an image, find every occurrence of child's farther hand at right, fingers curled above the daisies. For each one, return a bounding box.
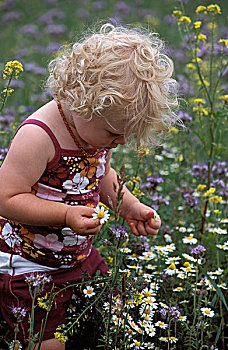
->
[125,202,161,236]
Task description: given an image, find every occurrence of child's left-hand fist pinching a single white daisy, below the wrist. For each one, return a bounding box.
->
[66,205,102,236]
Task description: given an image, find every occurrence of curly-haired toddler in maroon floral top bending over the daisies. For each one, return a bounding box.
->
[0,24,177,350]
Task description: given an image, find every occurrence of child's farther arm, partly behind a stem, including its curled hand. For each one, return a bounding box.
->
[101,155,161,236]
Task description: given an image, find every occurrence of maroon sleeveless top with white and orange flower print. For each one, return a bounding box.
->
[0,119,108,268]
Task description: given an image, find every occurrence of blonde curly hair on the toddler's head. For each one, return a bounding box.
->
[47,24,178,145]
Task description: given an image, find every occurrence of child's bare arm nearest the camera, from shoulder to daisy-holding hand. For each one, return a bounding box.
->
[0,125,101,234]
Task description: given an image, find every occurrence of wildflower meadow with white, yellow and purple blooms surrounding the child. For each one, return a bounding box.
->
[0,0,228,350]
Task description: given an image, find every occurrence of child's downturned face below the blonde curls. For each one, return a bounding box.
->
[73,110,126,148]
